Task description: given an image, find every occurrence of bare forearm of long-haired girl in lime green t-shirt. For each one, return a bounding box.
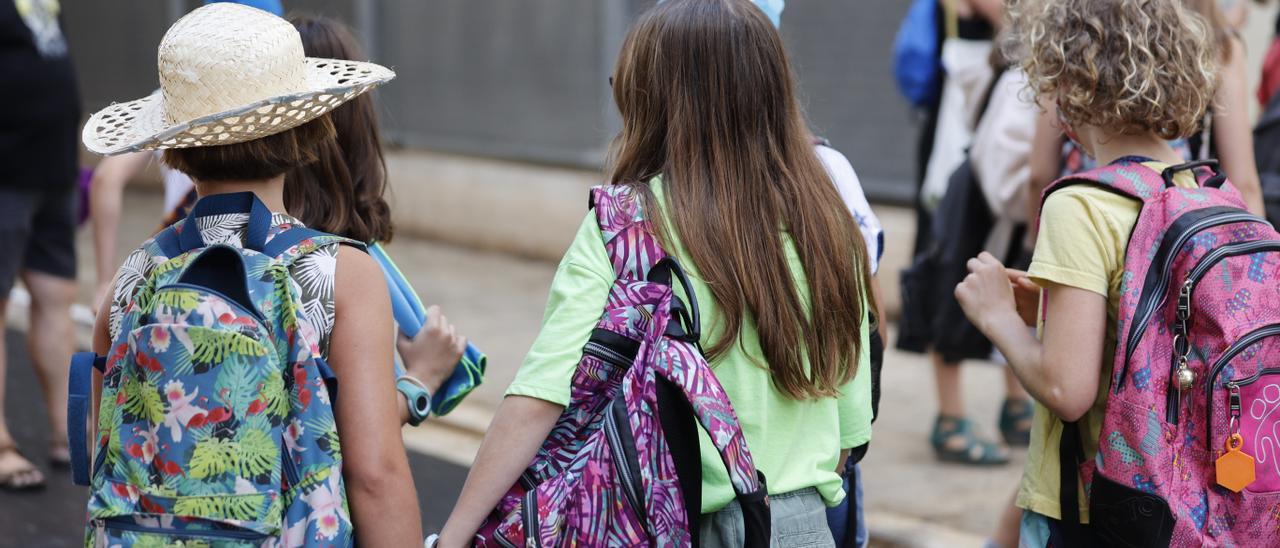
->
[436,396,564,548]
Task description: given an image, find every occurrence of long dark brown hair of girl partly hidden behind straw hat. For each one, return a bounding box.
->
[284,15,393,242]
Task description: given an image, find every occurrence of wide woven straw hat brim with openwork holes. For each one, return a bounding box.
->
[82,58,396,155]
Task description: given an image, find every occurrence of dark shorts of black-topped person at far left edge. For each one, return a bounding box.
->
[0,186,76,295]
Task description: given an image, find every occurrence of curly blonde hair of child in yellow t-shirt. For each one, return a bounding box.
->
[1002,0,1217,140]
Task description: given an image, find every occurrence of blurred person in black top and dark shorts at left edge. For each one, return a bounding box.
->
[0,0,81,489]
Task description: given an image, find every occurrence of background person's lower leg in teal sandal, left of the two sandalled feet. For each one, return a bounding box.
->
[929,352,1009,465]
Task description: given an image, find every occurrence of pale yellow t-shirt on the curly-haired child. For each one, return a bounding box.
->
[1016,161,1196,522]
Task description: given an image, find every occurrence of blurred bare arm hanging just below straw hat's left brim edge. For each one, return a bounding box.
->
[88,151,151,307]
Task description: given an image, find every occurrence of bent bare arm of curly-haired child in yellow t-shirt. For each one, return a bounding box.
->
[955,252,1107,421]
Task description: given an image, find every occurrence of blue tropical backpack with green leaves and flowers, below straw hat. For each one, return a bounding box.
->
[68,193,360,547]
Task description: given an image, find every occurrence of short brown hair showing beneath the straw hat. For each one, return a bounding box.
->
[164,117,334,182]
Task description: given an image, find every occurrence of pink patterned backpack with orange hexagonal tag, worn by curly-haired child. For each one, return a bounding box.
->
[1044,157,1280,547]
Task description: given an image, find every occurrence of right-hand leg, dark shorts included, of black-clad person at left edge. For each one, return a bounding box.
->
[22,188,76,465]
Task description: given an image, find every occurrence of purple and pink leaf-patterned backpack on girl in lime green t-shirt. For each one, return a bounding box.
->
[476,186,769,548]
